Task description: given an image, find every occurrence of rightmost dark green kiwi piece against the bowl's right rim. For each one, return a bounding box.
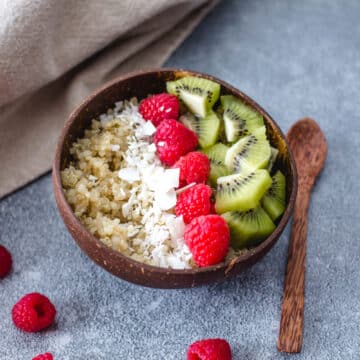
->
[262,170,286,221]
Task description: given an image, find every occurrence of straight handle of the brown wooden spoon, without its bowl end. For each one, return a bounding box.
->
[277,183,310,353]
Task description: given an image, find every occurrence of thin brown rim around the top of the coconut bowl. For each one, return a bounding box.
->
[52,67,298,275]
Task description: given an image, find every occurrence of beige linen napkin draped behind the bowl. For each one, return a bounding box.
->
[0,0,217,198]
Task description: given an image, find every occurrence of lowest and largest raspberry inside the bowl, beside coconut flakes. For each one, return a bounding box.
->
[184,215,230,267]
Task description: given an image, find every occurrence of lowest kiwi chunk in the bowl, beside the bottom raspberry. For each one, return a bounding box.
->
[221,206,275,250]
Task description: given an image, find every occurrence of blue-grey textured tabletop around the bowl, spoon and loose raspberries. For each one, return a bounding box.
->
[0,0,360,360]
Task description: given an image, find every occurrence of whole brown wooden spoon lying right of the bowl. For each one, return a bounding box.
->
[277,118,327,353]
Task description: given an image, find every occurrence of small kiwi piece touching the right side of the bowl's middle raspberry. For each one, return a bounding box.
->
[203,143,230,187]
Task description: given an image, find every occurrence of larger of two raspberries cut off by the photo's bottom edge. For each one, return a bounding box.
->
[187,339,231,360]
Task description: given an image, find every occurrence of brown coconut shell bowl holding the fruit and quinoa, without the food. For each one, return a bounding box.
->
[52,68,297,288]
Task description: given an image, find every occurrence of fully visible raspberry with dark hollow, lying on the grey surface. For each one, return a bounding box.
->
[12,293,56,332]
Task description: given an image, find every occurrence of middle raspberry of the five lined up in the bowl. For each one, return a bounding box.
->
[174,151,210,187]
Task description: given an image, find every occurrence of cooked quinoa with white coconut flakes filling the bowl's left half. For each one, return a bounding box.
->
[61,99,194,268]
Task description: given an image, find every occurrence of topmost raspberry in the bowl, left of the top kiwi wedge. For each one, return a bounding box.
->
[139,93,179,126]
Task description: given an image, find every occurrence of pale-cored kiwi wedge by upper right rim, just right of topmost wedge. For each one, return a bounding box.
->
[221,95,264,142]
